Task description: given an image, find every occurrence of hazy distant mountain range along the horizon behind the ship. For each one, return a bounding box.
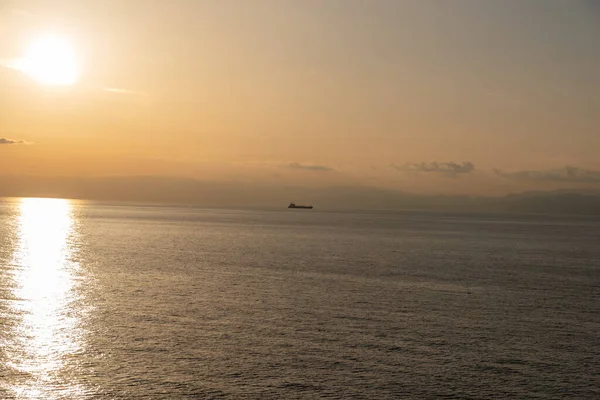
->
[0,176,600,215]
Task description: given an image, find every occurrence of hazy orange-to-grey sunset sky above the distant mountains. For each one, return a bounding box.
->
[0,0,600,200]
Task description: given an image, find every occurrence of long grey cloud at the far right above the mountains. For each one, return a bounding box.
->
[494,166,600,183]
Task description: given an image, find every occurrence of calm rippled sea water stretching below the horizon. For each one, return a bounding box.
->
[0,199,600,399]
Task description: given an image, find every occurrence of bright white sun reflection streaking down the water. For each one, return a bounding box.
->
[5,199,88,399]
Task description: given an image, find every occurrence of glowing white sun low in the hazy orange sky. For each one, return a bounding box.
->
[20,35,80,85]
